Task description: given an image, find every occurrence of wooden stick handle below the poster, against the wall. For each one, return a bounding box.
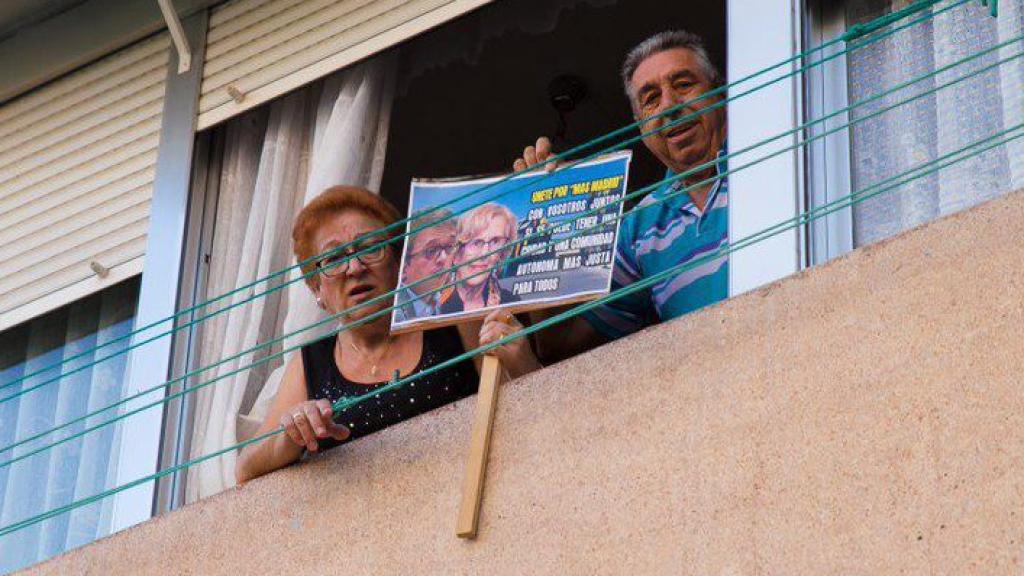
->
[456,356,502,538]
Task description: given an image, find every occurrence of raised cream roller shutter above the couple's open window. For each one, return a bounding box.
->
[199,0,490,129]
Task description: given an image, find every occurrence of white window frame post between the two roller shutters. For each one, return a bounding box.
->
[112,10,208,532]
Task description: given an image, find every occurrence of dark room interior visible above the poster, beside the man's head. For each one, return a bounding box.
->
[381,0,726,208]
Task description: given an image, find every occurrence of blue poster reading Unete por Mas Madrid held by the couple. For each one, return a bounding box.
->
[391,152,632,333]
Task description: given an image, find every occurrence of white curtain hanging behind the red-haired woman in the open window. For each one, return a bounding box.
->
[186,54,395,501]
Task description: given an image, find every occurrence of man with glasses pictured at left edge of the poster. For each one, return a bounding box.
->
[394,210,457,322]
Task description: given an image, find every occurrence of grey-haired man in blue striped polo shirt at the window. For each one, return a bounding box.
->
[514,31,729,360]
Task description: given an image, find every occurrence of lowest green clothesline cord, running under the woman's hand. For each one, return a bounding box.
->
[0,118,1024,537]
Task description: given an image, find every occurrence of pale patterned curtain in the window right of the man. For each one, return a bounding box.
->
[848,0,1024,246]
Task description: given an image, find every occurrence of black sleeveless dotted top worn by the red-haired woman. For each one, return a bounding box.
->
[302,327,479,451]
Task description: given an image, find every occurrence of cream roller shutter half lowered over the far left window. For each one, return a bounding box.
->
[0,34,170,330]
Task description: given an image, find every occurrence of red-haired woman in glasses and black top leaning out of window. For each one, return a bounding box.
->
[236,187,540,482]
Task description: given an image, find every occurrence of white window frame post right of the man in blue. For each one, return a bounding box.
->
[726,0,805,296]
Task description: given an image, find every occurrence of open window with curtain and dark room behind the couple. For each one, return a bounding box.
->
[174,0,727,501]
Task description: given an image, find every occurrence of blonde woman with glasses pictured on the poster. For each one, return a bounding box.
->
[440,202,518,314]
